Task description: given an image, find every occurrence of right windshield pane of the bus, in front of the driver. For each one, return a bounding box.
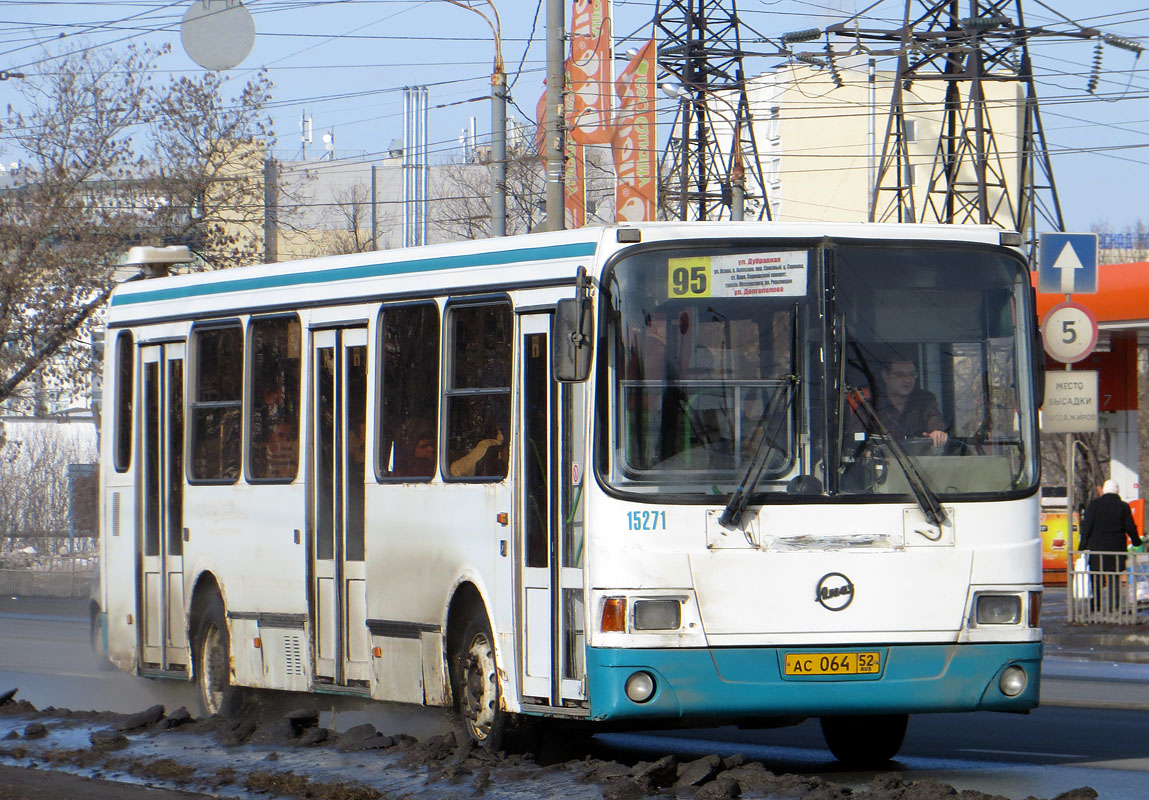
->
[833,245,1036,497]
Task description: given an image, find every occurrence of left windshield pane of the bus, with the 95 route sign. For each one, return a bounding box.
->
[604,247,812,497]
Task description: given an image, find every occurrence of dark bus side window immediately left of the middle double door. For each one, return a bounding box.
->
[247,316,301,480]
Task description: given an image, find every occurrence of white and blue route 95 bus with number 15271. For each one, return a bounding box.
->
[100,223,1042,761]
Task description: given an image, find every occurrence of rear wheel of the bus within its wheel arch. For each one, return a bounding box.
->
[188,574,240,717]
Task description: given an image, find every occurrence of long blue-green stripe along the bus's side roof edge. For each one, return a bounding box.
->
[111,241,596,306]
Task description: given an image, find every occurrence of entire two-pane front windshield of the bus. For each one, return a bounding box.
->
[597,241,1036,502]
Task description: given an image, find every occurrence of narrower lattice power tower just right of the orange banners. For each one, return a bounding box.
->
[654,0,770,220]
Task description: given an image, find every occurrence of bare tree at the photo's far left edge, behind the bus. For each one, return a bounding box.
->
[0,48,157,411]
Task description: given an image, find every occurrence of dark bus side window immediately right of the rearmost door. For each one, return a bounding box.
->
[191,324,244,483]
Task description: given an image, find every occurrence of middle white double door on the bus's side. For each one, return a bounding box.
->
[310,328,371,686]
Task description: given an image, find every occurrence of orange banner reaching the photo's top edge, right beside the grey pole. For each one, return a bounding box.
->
[566,0,614,145]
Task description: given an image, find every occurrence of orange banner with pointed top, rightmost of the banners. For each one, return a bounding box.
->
[611,37,658,222]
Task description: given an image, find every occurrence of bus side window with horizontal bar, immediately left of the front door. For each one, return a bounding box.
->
[445,302,512,480]
